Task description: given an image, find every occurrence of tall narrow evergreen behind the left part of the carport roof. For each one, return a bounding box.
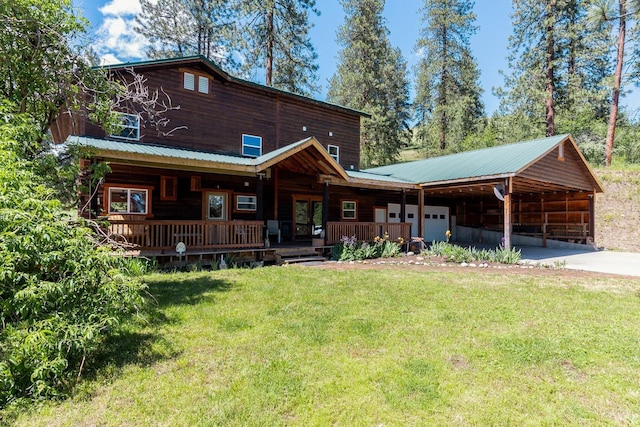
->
[415,0,484,150]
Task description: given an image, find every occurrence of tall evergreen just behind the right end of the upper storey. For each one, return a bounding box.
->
[327,0,410,167]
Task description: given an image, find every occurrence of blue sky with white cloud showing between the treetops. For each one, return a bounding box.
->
[74,0,637,115]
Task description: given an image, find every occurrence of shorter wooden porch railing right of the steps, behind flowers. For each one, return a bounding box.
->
[327,222,411,245]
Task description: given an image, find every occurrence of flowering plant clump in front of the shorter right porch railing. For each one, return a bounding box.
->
[331,233,404,261]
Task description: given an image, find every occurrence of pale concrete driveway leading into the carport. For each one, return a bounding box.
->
[518,246,640,277]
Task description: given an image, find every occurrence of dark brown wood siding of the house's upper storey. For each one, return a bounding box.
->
[77,68,360,169]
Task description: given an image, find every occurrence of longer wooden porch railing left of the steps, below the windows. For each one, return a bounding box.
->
[108,220,264,250]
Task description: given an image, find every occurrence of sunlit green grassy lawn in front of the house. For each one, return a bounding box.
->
[7,267,640,426]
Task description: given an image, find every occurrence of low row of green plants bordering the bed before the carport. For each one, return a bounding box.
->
[425,242,521,264]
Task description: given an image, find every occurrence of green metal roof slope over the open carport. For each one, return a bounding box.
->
[364,134,569,184]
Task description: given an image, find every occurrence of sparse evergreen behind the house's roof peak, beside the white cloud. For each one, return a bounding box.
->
[136,0,237,71]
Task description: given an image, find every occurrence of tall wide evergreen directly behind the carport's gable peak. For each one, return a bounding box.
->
[497,0,610,138]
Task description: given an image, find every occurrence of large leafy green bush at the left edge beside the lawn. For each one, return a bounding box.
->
[0,113,144,406]
